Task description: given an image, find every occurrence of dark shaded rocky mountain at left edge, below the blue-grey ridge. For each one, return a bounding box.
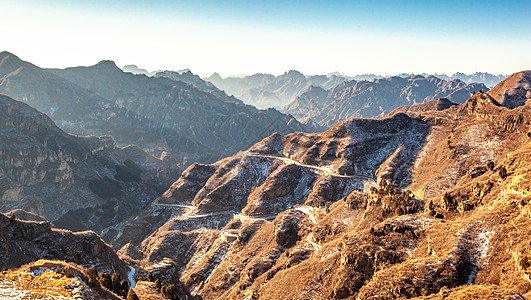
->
[0,95,179,231]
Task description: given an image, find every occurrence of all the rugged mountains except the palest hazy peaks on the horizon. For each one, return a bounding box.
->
[0,46,531,300]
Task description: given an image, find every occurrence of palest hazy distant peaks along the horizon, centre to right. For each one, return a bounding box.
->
[204,70,507,109]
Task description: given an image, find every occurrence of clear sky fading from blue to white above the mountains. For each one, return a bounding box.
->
[0,0,531,76]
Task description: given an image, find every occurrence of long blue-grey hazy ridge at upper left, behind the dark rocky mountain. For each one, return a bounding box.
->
[0,52,318,167]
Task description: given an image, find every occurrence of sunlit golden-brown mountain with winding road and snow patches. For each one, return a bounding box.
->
[113,72,531,299]
